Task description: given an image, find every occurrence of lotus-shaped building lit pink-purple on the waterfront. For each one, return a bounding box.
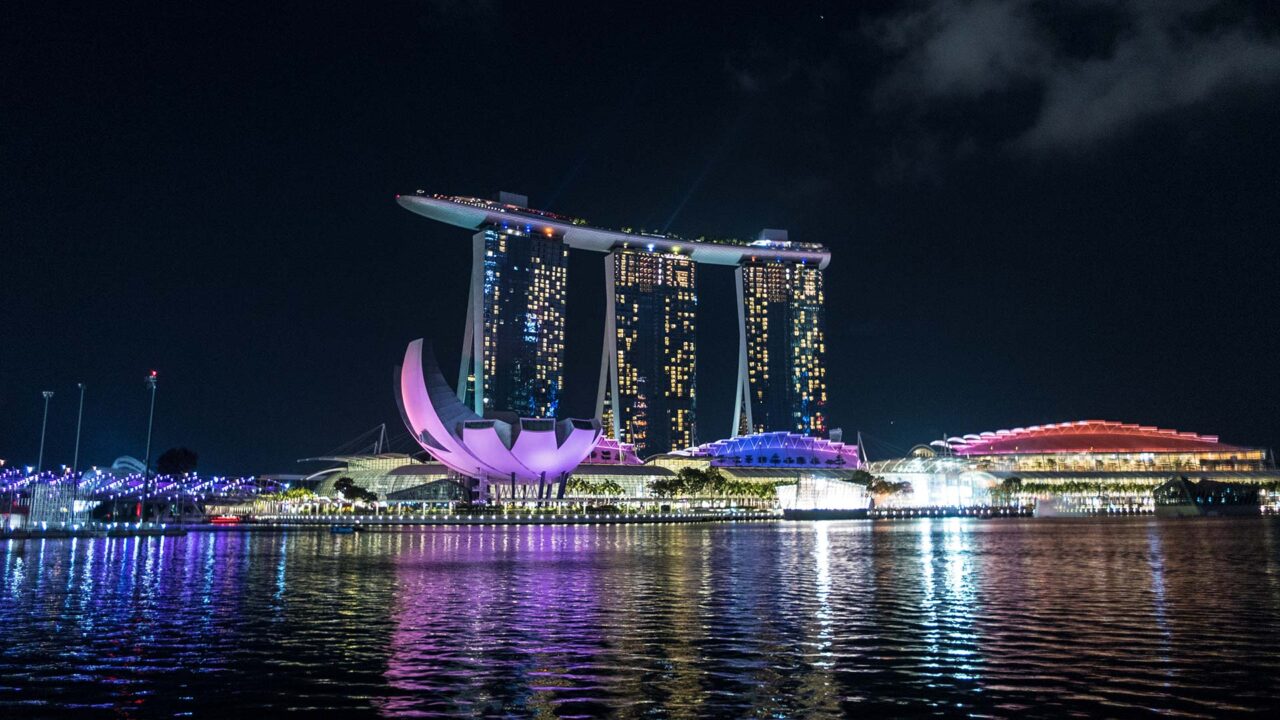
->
[398,340,600,500]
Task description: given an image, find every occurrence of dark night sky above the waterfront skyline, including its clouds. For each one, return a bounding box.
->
[0,0,1280,473]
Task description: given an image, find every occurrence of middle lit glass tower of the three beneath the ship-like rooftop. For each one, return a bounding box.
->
[596,249,698,457]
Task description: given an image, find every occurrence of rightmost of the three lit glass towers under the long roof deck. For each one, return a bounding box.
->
[733,252,827,434]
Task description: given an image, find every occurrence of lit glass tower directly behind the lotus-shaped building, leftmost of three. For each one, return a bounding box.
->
[457,223,568,418]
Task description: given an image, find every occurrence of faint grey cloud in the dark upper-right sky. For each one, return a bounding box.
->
[868,0,1280,151]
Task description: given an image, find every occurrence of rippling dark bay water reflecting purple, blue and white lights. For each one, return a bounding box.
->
[0,519,1280,717]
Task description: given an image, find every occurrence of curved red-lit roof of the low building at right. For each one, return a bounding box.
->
[933,420,1244,455]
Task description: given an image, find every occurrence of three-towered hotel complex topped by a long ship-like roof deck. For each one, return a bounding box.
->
[398,193,831,448]
